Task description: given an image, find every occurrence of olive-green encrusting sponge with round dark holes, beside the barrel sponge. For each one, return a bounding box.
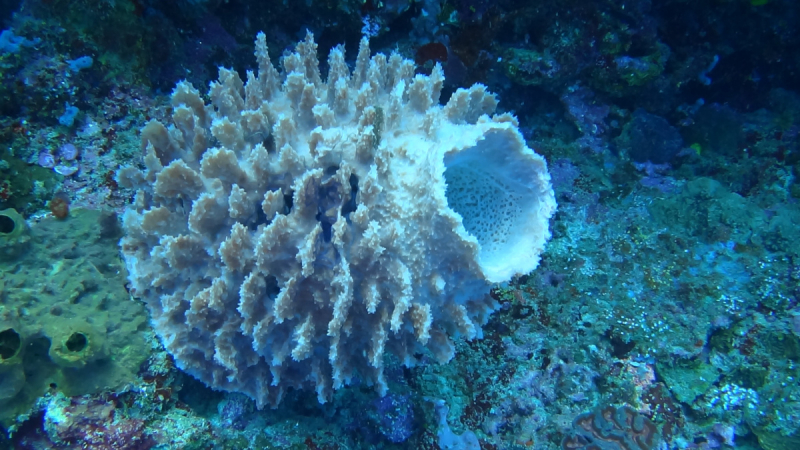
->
[0,210,151,426]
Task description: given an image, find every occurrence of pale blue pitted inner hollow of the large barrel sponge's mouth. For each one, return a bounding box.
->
[444,131,548,282]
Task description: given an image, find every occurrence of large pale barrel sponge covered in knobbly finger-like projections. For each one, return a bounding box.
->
[117,33,555,407]
